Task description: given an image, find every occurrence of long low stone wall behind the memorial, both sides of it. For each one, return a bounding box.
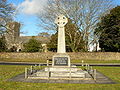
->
[0,52,120,60]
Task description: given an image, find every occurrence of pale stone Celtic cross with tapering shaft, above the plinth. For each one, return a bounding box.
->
[55,15,68,53]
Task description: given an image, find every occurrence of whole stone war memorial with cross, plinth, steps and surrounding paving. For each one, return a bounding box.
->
[9,15,114,84]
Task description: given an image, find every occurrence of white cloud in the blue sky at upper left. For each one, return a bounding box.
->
[18,0,48,15]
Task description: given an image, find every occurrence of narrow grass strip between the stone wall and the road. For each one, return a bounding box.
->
[0,58,120,63]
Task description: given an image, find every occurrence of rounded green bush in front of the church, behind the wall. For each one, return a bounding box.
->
[24,37,42,52]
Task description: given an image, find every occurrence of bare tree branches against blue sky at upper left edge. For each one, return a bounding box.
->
[0,0,15,34]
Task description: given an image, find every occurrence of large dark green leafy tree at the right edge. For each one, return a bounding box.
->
[95,6,120,52]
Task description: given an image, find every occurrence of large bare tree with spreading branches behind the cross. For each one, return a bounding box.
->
[38,0,113,50]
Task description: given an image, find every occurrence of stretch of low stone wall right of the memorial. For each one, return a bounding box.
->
[70,52,120,60]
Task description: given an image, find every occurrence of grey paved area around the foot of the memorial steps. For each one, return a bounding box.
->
[8,71,116,84]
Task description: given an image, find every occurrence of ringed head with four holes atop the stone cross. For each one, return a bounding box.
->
[55,15,68,27]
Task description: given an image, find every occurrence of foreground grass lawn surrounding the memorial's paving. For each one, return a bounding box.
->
[0,65,120,90]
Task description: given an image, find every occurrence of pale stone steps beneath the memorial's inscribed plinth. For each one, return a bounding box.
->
[33,67,88,78]
